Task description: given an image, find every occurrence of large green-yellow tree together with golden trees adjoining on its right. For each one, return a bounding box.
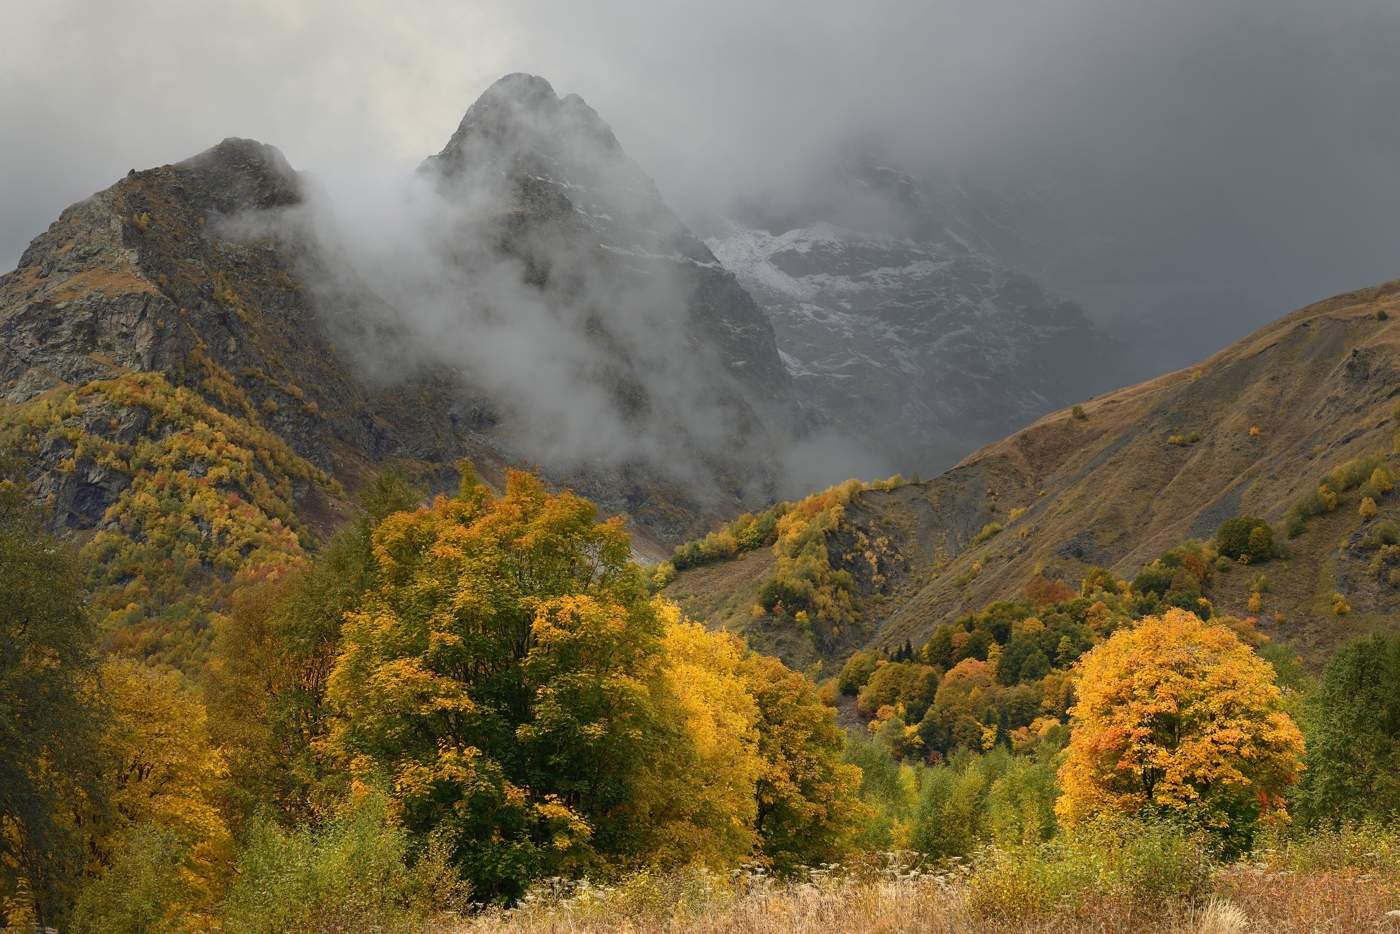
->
[319,472,857,900]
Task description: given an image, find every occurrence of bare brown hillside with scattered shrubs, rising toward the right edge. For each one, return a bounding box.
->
[666,281,1400,664]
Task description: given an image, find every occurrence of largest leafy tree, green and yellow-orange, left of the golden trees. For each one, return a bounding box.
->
[326,472,641,898]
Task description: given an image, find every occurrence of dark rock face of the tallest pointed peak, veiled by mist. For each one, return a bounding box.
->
[420,74,804,492]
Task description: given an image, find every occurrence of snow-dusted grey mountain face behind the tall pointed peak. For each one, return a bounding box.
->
[708,162,1121,471]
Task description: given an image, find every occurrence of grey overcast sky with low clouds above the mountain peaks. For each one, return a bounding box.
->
[0,0,1400,355]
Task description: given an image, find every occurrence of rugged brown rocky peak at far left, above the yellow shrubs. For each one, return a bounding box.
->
[0,140,487,537]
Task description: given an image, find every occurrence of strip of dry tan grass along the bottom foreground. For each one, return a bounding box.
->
[440,867,1400,934]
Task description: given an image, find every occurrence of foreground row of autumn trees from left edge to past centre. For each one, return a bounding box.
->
[0,468,865,931]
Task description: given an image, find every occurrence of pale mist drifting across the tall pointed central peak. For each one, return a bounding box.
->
[211,74,889,504]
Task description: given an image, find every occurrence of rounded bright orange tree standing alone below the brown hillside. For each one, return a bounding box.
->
[1056,609,1303,846]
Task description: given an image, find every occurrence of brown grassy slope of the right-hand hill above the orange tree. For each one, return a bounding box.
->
[672,281,1400,658]
